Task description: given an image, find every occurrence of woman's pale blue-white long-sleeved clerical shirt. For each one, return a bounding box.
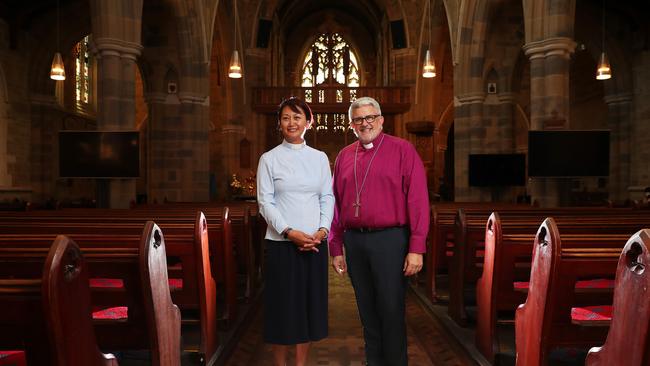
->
[257,141,334,241]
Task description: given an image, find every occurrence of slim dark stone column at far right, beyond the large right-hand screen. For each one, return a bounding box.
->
[605,93,632,202]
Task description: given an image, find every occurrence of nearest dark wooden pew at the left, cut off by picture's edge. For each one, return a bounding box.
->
[0,236,117,366]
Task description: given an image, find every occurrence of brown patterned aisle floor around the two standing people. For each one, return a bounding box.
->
[226,268,475,366]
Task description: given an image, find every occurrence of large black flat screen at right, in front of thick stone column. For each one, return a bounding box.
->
[528,130,609,177]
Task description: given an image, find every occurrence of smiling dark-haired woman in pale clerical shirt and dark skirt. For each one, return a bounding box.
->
[257,97,334,366]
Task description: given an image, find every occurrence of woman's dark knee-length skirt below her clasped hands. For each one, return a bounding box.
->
[264,240,328,345]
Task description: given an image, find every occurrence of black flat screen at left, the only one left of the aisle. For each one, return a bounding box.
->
[59,131,140,178]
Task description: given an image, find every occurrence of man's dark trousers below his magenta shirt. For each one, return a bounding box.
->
[343,228,409,366]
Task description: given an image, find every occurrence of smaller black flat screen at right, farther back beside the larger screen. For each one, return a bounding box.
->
[469,154,526,187]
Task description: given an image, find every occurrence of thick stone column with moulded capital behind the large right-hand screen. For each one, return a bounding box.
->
[523,37,576,207]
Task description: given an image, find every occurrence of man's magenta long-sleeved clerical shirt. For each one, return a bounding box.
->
[329,133,429,256]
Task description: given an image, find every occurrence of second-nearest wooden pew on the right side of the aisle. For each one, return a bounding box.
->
[515,218,623,366]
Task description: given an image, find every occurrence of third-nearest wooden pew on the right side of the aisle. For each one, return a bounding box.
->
[476,212,629,362]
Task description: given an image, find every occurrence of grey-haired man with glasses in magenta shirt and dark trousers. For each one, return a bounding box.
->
[329,97,429,366]
